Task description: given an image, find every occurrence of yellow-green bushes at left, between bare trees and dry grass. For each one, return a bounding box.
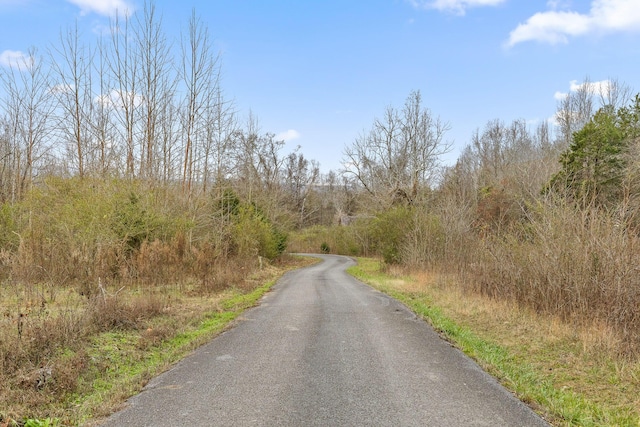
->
[0,178,286,286]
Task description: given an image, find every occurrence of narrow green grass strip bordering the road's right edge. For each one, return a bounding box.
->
[348,258,640,426]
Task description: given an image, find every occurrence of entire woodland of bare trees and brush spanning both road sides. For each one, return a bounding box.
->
[0,4,640,421]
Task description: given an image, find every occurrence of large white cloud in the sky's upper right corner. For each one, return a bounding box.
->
[506,0,640,47]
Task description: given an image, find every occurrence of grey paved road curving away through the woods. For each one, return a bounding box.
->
[105,255,547,427]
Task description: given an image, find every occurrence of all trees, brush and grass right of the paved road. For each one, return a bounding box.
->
[290,80,640,425]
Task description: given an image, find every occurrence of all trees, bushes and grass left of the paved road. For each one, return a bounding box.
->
[0,2,320,426]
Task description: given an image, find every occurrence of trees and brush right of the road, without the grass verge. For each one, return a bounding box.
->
[320,78,640,354]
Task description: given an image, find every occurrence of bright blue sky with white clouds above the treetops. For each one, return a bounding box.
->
[0,0,640,171]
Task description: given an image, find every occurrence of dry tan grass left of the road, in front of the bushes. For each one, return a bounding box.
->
[0,254,304,425]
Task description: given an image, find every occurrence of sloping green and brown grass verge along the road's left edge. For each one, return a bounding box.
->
[0,257,317,427]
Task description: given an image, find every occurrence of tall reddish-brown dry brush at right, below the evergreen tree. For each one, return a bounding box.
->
[401,200,640,358]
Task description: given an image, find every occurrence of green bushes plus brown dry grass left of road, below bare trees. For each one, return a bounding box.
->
[0,177,287,422]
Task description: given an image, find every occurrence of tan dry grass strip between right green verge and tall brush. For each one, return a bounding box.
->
[385,267,640,419]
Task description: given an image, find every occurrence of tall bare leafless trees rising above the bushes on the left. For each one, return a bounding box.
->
[0,2,318,212]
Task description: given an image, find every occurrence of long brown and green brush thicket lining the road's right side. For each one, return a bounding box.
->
[292,193,640,355]
